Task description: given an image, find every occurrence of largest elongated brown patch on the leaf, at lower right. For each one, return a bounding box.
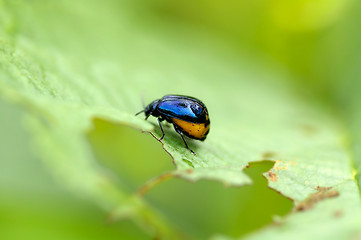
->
[295,186,340,212]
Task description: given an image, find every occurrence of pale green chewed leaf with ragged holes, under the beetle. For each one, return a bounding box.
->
[0,1,361,239]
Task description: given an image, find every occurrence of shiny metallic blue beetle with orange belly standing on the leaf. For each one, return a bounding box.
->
[136,95,210,155]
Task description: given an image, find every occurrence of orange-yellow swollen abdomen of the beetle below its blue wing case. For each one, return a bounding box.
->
[171,118,210,140]
